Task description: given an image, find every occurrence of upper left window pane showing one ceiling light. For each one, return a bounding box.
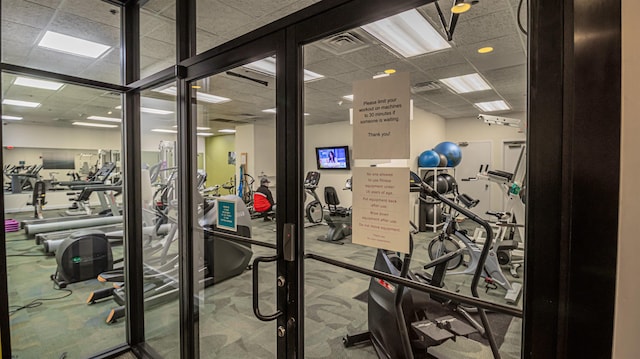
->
[2,0,120,84]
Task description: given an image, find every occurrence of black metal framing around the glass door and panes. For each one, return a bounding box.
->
[0,0,621,358]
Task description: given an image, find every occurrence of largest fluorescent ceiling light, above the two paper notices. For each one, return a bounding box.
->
[362,9,451,57]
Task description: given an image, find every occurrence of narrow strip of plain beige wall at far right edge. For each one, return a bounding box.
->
[612,0,640,358]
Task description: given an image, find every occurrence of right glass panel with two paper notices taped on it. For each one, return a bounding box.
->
[299,2,527,358]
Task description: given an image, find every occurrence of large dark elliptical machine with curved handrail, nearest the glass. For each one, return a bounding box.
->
[343,173,500,359]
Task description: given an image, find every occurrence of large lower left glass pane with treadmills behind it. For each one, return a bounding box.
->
[2,71,125,358]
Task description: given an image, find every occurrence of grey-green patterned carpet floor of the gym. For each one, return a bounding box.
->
[7,210,521,359]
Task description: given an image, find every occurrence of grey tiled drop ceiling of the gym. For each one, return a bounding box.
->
[2,0,526,127]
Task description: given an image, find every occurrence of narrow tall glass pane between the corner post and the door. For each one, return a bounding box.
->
[140,85,181,358]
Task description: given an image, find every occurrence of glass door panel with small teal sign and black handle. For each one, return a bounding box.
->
[191,59,276,358]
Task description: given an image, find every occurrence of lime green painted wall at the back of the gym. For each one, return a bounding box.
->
[205,135,236,188]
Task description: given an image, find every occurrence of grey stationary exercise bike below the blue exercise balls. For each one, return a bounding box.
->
[425,197,522,303]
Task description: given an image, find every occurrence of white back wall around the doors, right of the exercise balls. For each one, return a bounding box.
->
[445,113,526,210]
